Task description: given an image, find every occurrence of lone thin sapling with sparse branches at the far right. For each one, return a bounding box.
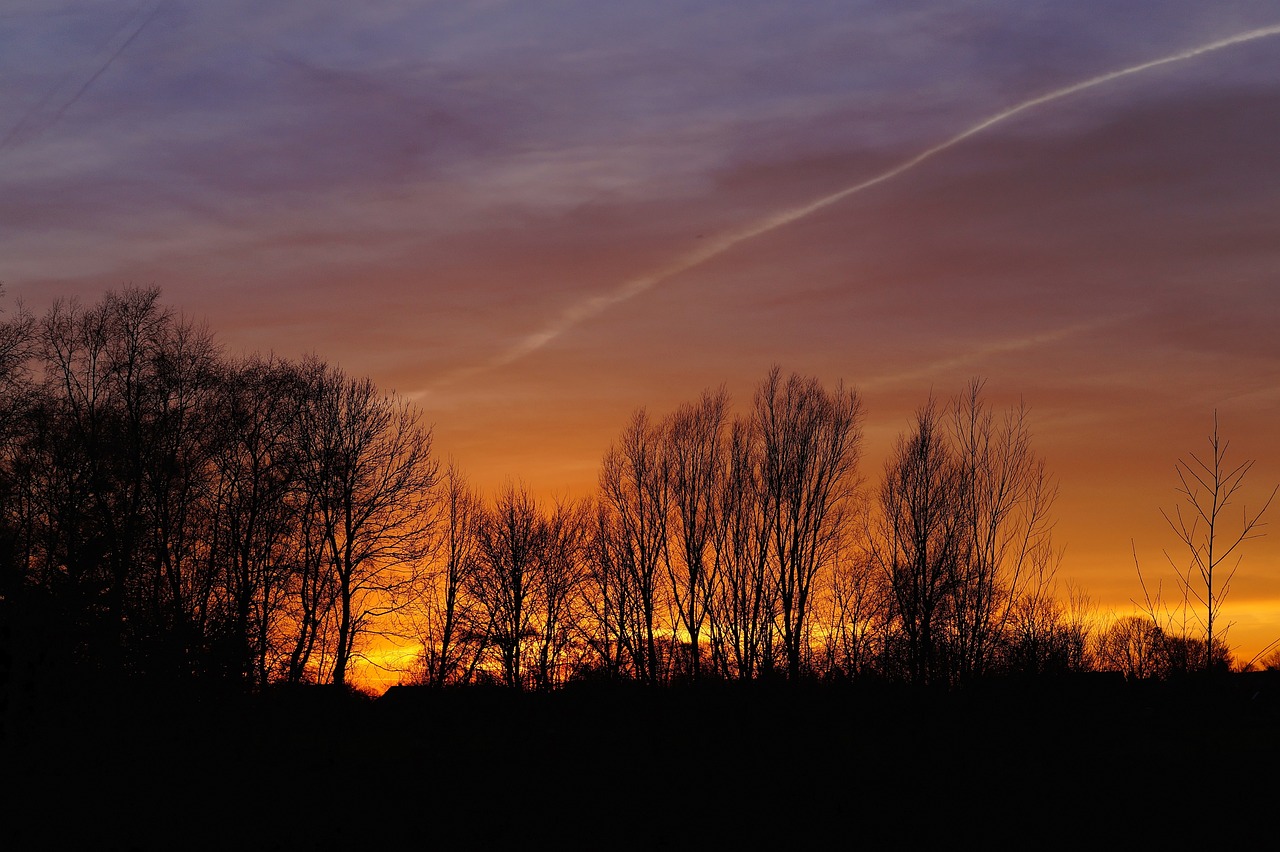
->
[1157,412,1280,670]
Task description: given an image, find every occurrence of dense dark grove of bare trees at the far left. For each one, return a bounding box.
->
[0,289,436,683]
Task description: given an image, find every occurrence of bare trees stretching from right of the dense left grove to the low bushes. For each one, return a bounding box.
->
[419,368,1091,687]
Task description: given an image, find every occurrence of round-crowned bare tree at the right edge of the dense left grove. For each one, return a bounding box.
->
[298,359,438,686]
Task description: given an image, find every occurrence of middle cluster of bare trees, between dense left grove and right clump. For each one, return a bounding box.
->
[404,370,861,687]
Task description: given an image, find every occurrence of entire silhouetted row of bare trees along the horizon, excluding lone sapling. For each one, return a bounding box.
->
[0,288,1264,690]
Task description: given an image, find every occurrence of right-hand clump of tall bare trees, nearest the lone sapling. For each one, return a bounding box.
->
[867,381,1084,683]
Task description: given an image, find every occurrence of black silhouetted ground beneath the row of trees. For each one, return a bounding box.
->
[0,675,1280,851]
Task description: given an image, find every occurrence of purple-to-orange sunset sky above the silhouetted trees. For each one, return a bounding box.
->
[0,0,1280,659]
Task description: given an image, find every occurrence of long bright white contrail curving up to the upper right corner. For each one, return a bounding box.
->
[440,24,1280,383]
